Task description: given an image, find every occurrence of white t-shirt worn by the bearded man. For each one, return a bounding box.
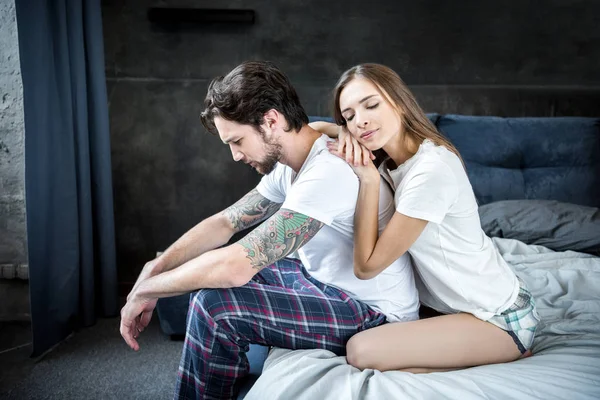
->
[257,135,419,322]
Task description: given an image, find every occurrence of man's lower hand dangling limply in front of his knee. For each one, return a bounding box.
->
[120,290,158,351]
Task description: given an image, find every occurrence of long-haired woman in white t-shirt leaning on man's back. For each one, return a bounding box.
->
[318,64,539,373]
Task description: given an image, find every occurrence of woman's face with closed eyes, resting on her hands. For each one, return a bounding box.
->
[340,77,402,150]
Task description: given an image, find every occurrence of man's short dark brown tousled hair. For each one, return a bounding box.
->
[200,61,308,134]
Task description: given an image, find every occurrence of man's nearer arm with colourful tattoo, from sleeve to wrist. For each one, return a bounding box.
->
[136,209,323,299]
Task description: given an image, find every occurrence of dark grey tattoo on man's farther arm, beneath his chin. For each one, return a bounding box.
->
[223,189,281,232]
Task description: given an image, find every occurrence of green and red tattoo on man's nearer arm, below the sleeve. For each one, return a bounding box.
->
[238,210,323,269]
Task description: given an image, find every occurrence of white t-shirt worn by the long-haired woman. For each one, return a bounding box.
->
[379,139,519,321]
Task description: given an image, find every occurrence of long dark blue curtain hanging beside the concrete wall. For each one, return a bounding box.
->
[15,0,118,356]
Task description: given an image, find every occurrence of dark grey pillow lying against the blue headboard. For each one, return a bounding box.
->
[479,200,600,255]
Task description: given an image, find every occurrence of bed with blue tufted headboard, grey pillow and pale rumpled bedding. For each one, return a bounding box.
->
[245,115,600,400]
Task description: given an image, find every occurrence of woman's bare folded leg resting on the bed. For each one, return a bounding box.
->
[346,313,521,373]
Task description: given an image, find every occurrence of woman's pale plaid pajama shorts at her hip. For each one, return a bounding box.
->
[488,277,540,354]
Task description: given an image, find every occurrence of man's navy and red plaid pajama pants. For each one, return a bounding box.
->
[175,259,385,399]
